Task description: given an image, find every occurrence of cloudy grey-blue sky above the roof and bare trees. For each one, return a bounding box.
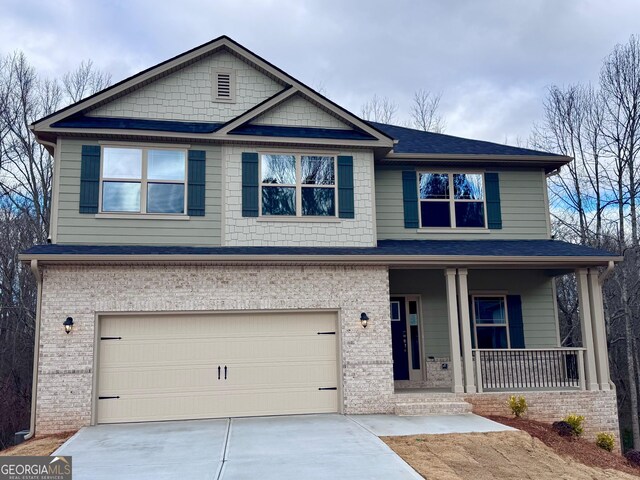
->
[0,0,640,144]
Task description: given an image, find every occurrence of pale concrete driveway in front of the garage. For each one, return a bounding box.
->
[55,415,506,480]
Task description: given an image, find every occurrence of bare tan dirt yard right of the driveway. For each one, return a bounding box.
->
[382,431,640,480]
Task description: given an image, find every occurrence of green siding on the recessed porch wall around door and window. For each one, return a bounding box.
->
[389,270,558,357]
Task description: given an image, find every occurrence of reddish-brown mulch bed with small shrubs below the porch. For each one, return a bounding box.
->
[487,415,640,476]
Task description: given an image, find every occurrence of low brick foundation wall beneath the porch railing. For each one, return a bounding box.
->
[464,390,620,440]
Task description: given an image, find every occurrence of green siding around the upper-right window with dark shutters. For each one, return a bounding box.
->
[375,168,549,240]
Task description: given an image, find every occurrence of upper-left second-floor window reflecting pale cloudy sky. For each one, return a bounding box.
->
[101,147,186,214]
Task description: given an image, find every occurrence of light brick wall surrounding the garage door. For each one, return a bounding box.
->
[36,266,393,434]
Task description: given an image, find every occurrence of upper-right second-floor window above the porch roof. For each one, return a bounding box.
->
[418,172,486,228]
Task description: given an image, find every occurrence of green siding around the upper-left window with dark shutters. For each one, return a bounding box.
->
[56,139,222,246]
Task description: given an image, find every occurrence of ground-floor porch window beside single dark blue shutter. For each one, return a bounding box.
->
[473,295,510,348]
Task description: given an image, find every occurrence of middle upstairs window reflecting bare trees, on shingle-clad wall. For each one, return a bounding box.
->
[260,154,336,217]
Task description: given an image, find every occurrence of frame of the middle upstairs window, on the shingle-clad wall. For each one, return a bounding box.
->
[258,151,338,220]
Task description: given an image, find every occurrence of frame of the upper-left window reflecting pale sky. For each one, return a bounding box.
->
[98,145,189,217]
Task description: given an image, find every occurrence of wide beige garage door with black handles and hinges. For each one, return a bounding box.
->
[97,312,338,423]
